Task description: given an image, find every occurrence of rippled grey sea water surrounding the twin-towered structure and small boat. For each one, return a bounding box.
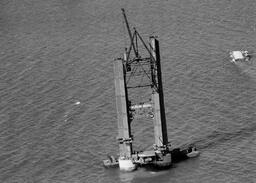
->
[0,0,256,183]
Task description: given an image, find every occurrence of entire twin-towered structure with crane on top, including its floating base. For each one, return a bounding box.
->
[105,9,199,171]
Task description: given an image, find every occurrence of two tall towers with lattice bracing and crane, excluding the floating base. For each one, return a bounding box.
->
[114,9,168,160]
